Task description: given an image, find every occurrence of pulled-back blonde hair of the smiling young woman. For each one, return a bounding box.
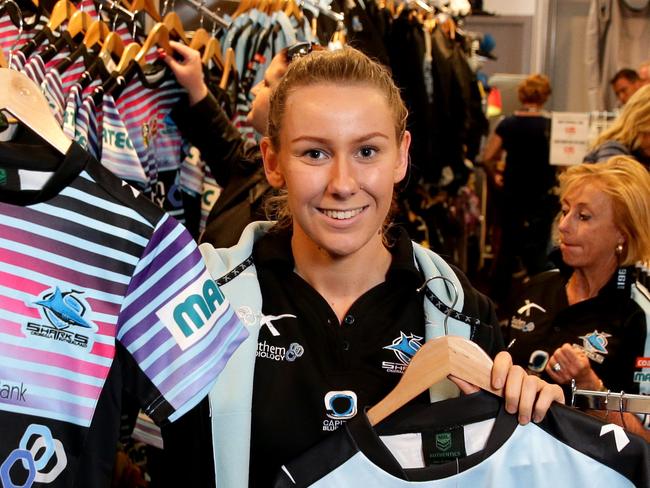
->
[265,47,408,232]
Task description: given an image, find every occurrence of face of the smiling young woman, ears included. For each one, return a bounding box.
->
[262,83,410,257]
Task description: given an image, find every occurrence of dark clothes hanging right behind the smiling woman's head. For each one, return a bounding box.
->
[326,0,488,268]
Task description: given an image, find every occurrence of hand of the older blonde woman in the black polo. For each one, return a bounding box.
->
[546,344,603,390]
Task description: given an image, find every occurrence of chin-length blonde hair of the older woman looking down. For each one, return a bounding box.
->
[559,156,650,266]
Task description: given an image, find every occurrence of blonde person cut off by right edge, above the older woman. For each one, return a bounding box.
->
[584,85,650,168]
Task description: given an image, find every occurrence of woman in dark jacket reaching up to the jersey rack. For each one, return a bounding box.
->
[164,41,322,247]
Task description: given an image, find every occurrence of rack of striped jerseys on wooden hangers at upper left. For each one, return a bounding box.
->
[0,0,308,236]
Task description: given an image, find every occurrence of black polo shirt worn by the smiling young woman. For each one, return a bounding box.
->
[250,230,424,486]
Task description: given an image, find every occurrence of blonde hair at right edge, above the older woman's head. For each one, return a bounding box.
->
[592,85,650,151]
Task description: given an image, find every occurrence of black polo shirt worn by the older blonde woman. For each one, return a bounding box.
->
[508,267,650,400]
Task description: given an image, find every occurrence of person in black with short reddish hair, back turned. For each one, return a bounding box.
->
[483,75,558,303]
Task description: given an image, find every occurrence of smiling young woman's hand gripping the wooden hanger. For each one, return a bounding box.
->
[452,351,564,425]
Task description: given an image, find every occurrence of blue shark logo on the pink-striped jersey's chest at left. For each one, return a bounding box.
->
[23,286,98,350]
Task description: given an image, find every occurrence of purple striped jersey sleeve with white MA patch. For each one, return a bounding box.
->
[117,215,248,423]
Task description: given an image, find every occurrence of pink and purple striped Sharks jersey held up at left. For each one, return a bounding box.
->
[0,139,247,488]
